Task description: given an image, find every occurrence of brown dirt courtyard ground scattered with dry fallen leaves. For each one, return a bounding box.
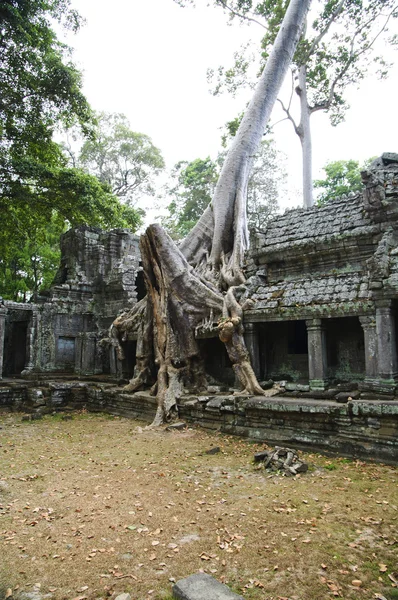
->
[0,414,398,600]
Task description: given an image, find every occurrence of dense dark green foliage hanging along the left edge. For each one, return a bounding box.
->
[0,0,145,300]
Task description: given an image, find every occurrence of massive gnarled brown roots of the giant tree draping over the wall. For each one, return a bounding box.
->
[112,225,263,425]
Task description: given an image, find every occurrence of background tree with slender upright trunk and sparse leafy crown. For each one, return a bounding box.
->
[204,0,398,206]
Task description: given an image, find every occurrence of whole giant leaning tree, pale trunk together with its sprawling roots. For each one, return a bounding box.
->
[112,0,310,424]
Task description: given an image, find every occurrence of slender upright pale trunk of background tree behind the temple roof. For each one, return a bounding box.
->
[296,65,314,208]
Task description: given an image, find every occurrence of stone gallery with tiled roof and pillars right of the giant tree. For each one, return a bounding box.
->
[245,154,398,392]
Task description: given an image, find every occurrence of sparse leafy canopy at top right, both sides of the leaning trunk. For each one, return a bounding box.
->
[209,0,398,125]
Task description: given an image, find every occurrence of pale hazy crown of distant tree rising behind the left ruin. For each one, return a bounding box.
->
[79,113,164,205]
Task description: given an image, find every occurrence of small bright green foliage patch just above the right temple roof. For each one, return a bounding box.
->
[314,159,373,206]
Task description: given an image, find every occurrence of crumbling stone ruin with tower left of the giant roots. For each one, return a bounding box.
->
[0,227,145,377]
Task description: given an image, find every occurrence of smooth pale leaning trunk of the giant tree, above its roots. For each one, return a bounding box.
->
[181,0,310,288]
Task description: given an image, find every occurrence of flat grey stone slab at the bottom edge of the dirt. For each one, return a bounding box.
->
[173,573,243,600]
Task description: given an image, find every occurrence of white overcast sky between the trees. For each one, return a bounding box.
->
[63,0,398,213]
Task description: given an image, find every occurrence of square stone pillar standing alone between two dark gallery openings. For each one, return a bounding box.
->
[306,319,327,390]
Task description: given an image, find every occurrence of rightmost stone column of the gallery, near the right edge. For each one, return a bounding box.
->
[376,306,398,387]
